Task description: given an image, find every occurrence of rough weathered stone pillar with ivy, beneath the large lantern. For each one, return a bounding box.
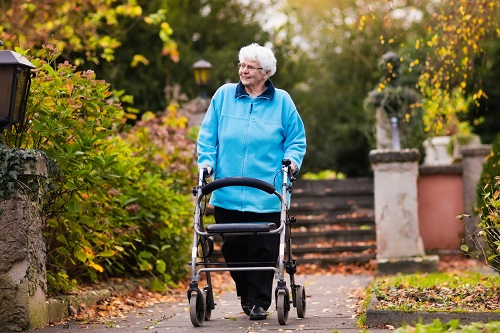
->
[0,150,48,332]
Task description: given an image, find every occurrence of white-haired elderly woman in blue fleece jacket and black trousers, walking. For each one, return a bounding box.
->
[197,43,306,320]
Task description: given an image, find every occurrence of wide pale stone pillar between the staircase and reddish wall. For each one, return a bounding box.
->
[370,149,439,274]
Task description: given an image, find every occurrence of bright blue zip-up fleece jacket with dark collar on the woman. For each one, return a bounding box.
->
[197,80,306,213]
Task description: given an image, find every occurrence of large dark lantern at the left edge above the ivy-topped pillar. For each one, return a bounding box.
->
[0,50,35,134]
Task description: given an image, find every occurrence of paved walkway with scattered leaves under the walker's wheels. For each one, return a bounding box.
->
[37,274,388,333]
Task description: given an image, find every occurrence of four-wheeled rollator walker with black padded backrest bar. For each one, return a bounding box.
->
[187,160,306,327]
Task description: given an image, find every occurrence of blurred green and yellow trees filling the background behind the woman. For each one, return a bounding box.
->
[0,0,499,176]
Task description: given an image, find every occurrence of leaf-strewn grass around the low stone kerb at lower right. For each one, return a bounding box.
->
[357,262,500,333]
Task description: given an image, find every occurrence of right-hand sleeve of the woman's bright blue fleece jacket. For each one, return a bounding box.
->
[284,110,307,172]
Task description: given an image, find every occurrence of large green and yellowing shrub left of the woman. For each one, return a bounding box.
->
[7,48,196,293]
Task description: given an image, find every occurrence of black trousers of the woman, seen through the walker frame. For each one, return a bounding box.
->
[214,207,280,310]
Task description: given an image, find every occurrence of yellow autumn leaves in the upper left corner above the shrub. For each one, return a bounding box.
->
[0,0,179,65]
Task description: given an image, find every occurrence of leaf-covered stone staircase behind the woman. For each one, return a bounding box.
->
[203,178,376,266]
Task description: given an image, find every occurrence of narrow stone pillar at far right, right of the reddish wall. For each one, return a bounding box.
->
[460,145,491,247]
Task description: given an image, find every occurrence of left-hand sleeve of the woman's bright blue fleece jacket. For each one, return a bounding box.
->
[197,100,219,170]
